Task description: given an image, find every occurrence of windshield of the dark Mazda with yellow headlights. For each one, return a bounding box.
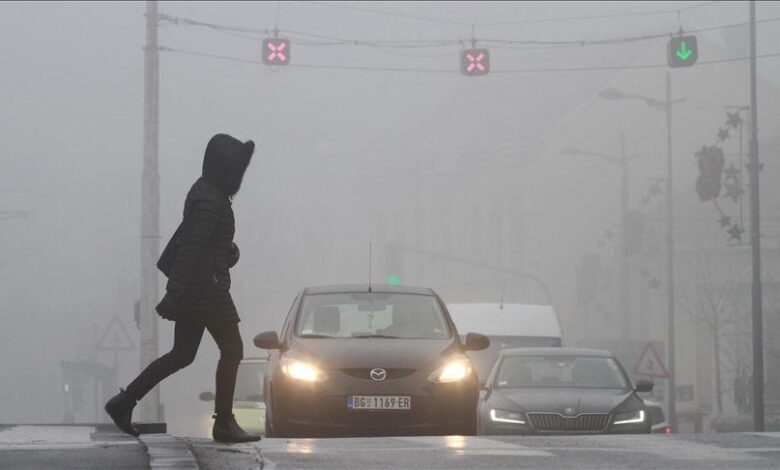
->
[296,292,450,339]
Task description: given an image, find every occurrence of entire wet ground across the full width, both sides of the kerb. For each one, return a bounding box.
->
[6,426,780,470]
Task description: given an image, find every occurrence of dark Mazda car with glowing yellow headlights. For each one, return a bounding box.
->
[255,285,489,437]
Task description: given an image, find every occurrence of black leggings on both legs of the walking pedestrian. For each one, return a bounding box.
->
[125,321,244,416]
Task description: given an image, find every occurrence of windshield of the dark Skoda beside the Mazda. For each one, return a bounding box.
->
[495,355,628,390]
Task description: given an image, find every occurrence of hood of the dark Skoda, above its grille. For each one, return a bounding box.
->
[495,388,641,414]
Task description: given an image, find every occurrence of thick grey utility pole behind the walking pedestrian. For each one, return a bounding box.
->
[140,0,162,421]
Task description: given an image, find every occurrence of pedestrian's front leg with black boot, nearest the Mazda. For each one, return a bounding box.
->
[207,323,260,442]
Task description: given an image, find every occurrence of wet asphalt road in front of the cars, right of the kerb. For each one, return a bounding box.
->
[189,433,780,470]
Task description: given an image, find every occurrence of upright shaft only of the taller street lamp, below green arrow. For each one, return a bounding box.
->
[665,70,677,432]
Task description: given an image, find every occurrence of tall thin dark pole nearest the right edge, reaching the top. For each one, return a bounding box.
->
[748,0,764,432]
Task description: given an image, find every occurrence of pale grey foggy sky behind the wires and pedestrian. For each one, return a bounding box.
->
[0,2,780,431]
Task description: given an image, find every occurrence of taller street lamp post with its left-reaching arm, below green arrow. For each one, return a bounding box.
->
[599,72,685,430]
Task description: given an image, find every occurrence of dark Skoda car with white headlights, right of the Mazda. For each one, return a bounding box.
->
[478,348,653,435]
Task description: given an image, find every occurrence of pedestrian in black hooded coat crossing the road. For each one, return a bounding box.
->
[105,134,260,442]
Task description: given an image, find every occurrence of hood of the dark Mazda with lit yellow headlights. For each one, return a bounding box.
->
[291,338,458,370]
